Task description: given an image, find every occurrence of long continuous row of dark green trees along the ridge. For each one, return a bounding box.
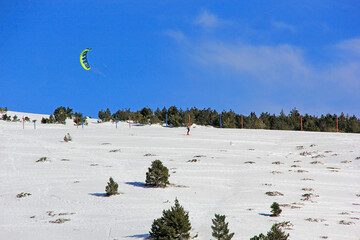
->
[98,106,360,133]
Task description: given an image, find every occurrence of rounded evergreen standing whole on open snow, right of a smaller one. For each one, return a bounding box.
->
[145,160,170,187]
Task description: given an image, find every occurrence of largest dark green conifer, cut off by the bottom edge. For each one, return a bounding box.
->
[149,199,191,240]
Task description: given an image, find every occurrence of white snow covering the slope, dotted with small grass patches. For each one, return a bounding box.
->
[0,112,360,240]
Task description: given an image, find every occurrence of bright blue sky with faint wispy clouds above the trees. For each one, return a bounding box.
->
[0,0,360,117]
